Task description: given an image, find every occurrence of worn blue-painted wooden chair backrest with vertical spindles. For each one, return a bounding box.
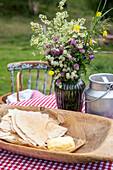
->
[7,61,53,94]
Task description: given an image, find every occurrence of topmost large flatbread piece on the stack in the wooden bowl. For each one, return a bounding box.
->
[15,112,49,146]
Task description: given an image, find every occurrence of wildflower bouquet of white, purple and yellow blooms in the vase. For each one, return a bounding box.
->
[31,0,111,85]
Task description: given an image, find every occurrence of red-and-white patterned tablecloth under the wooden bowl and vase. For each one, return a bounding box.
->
[0,95,113,170]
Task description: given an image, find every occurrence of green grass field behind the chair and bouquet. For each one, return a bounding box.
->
[0,0,113,95]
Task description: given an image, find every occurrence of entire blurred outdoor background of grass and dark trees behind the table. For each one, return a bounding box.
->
[0,0,113,95]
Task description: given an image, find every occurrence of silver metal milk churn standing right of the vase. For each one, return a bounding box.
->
[83,73,113,118]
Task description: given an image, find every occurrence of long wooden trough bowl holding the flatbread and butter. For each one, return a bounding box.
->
[0,105,113,163]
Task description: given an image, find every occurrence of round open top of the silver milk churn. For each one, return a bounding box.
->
[89,73,113,85]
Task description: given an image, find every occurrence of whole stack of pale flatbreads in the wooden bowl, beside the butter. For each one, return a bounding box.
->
[0,109,67,148]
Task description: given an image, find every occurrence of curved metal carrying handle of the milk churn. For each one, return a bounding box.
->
[82,84,113,102]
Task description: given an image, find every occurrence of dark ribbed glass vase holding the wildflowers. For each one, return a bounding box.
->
[55,79,85,111]
